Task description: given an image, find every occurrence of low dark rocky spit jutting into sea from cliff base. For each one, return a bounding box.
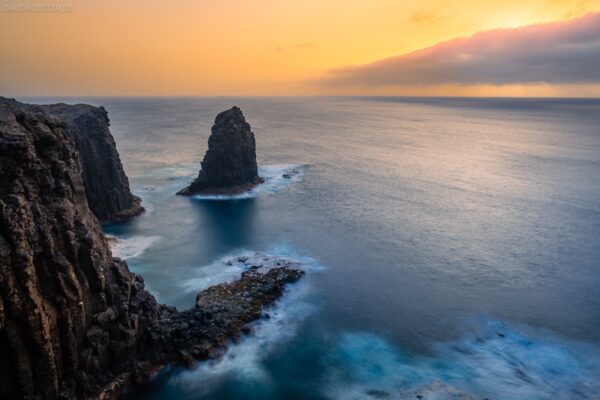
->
[97,259,304,399]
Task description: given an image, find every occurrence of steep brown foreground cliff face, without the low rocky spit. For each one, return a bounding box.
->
[0,99,162,399]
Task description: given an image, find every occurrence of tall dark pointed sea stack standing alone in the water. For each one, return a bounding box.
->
[178,107,263,195]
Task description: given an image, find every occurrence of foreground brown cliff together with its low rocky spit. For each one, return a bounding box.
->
[0,102,302,400]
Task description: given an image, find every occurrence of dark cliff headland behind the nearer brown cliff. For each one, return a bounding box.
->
[0,97,144,223]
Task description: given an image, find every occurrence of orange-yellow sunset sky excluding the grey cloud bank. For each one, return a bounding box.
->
[0,0,600,96]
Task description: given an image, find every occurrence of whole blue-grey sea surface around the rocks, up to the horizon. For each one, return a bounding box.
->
[29,98,600,399]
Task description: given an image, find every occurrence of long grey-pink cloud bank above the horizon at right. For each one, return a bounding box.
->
[320,13,600,87]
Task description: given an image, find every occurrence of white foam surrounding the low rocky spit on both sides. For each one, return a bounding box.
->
[170,248,321,394]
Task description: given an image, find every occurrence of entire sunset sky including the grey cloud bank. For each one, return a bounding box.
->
[0,0,600,97]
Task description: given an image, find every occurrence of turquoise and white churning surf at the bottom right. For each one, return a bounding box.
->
[324,321,600,400]
